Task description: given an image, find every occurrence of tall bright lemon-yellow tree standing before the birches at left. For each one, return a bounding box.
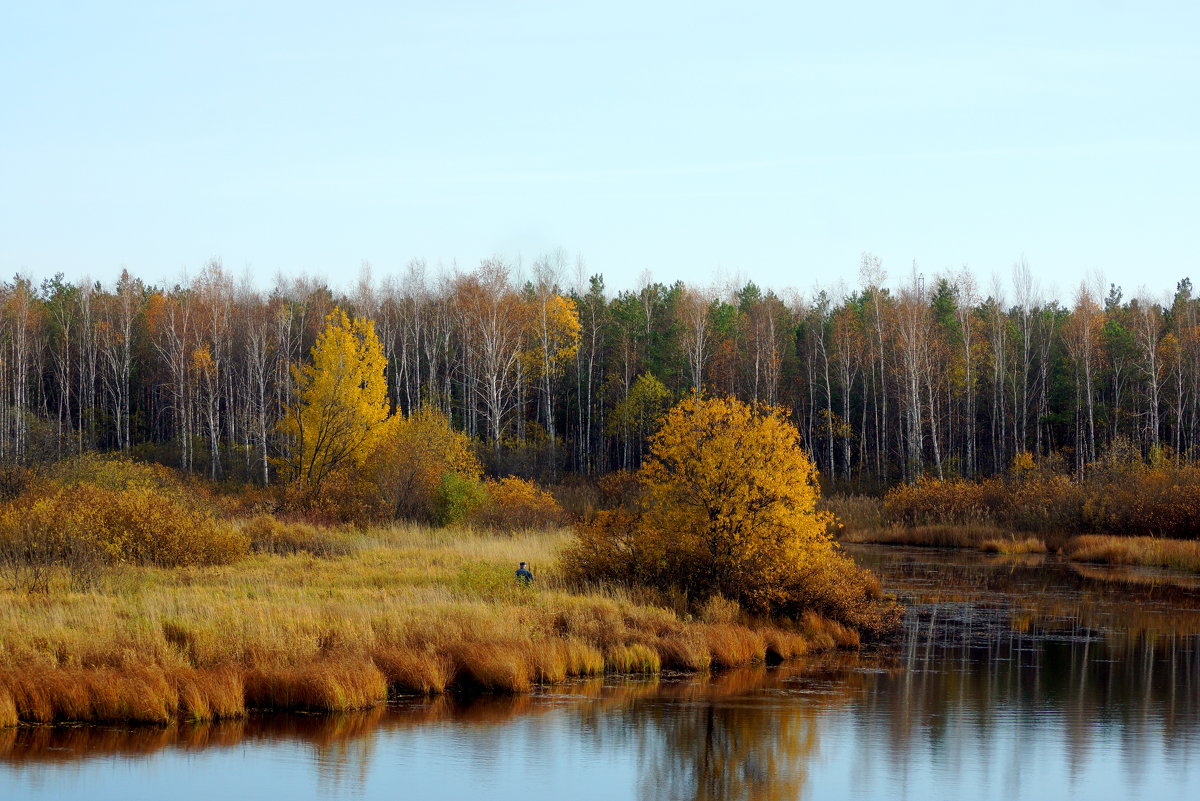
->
[280,308,389,489]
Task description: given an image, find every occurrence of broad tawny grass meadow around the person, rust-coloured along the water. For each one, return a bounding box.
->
[0,526,858,725]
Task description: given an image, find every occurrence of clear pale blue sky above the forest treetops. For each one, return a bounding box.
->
[0,0,1200,296]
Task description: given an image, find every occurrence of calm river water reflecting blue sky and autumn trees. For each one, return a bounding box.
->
[0,547,1200,801]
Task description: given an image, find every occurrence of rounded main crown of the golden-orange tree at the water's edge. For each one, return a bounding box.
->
[641,397,833,610]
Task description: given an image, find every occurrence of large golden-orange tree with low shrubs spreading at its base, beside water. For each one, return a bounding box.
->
[564,396,899,632]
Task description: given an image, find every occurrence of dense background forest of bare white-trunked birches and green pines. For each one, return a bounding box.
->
[0,251,1200,489]
